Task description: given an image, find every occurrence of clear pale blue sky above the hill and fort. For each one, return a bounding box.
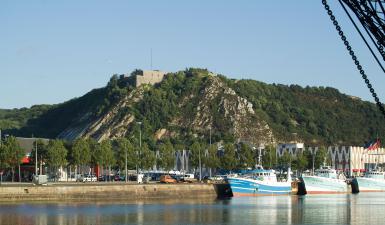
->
[0,0,385,109]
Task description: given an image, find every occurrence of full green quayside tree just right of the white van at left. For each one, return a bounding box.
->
[46,140,67,181]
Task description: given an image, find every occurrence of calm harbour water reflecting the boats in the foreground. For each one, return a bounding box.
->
[0,193,385,225]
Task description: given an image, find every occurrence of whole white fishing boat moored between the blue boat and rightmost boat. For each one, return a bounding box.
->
[298,166,350,195]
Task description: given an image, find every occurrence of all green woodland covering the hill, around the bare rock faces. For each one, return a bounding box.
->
[0,69,385,146]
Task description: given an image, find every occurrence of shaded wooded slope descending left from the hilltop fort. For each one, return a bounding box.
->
[0,75,132,138]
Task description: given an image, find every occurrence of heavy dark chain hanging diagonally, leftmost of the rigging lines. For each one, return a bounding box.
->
[322,0,385,118]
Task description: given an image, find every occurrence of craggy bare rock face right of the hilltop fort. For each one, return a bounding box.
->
[173,76,274,144]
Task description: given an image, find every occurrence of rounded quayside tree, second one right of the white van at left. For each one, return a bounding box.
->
[70,138,91,173]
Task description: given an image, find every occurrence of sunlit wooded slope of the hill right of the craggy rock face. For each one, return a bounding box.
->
[224,78,385,145]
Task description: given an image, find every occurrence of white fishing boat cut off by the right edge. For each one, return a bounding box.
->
[356,170,385,192]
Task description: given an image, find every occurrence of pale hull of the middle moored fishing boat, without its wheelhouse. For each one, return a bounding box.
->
[301,176,349,194]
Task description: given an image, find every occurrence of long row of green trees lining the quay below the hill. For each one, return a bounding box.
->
[0,136,332,180]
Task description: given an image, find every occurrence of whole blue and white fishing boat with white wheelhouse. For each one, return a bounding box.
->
[227,165,291,196]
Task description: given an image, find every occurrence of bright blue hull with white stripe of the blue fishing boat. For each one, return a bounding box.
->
[228,178,291,196]
